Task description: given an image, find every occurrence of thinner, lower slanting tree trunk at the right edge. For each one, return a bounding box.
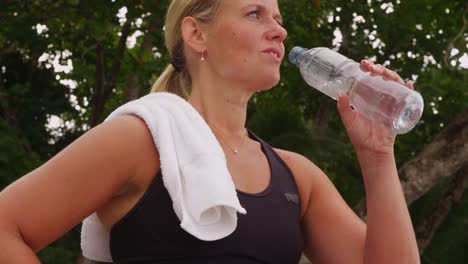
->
[416,163,468,255]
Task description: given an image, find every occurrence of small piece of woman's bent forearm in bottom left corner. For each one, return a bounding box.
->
[0,230,40,264]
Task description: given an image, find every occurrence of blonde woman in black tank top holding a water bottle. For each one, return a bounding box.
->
[0,0,419,263]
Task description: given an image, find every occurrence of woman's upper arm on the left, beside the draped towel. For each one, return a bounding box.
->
[0,116,157,251]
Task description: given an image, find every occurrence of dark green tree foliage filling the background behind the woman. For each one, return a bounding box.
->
[0,0,468,263]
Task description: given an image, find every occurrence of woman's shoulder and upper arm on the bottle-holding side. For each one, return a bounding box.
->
[276,151,366,263]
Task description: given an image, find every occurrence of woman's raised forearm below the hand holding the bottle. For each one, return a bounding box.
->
[358,153,420,264]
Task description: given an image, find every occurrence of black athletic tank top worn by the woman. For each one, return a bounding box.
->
[110,131,302,264]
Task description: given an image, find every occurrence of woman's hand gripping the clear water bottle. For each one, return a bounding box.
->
[338,60,413,154]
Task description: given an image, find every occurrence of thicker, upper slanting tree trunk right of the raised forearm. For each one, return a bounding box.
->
[354,108,468,217]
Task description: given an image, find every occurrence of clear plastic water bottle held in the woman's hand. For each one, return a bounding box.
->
[289,47,424,134]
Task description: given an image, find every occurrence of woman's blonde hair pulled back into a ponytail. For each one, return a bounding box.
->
[151,0,221,99]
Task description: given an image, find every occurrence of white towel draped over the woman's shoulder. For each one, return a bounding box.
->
[81,93,246,262]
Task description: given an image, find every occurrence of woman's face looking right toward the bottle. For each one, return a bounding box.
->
[205,0,287,90]
